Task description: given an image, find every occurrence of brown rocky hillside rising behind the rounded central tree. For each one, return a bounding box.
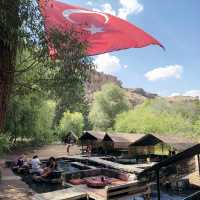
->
[86,71,158,106]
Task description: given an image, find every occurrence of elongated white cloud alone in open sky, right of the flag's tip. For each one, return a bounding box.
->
[145,65,183,81]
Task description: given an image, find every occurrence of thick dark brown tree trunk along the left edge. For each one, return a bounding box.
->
[0,0,20,133]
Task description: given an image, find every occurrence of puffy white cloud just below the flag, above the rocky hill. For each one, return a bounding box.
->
[94,53,125,74]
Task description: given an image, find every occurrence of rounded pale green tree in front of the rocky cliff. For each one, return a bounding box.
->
[89,83,130,130]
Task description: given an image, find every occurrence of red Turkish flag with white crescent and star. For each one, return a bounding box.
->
[41,0,164,55]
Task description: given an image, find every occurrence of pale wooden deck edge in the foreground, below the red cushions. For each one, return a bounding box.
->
[32,180,150,200]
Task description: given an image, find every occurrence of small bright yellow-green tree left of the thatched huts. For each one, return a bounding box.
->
[59,111,84,137]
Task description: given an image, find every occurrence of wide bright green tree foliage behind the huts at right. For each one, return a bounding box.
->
[115,98,200,136]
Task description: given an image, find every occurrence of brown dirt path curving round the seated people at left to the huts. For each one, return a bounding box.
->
[0,144,80,200]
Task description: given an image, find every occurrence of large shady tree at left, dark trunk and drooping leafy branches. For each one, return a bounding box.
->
[0,0,93,133]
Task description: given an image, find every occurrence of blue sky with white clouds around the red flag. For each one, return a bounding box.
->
[57,0,200,96]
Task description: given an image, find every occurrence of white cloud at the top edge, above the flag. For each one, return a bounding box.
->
[118,0,144,19]
